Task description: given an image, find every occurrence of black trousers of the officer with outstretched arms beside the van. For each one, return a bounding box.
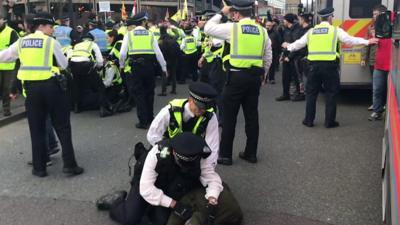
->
[304,61,340,126]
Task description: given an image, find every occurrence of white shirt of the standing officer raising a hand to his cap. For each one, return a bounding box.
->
[204,14,272,75]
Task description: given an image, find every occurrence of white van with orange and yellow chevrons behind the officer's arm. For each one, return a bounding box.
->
[313,0,393,88]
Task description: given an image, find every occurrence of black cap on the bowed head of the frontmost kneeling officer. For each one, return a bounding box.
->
[170,132,211,162]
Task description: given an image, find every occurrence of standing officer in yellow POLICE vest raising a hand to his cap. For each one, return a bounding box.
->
[204,0,272,165]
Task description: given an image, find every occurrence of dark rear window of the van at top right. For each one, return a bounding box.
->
[349,0,382,18]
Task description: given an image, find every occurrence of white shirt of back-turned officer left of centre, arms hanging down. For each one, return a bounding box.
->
[119,26,167,72]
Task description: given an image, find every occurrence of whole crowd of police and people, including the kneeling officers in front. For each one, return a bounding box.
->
[0,0,386,225]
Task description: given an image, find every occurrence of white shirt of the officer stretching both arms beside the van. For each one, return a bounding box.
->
[287,21,369,52]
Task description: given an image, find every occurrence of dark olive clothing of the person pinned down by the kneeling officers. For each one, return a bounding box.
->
[167,184,243,225]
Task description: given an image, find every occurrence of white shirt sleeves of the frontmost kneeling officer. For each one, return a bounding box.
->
[139,145,224,207]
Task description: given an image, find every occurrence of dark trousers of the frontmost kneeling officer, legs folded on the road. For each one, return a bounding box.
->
[110,185,171,225]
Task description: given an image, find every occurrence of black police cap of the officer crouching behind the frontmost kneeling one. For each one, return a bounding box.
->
[189,82,218,109]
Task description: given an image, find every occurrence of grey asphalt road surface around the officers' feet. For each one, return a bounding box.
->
[0,76,384,225]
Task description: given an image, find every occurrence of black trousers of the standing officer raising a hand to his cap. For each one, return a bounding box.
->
[219,70,261,158]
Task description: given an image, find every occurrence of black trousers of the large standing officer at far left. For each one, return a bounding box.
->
[24,78,77,171]
